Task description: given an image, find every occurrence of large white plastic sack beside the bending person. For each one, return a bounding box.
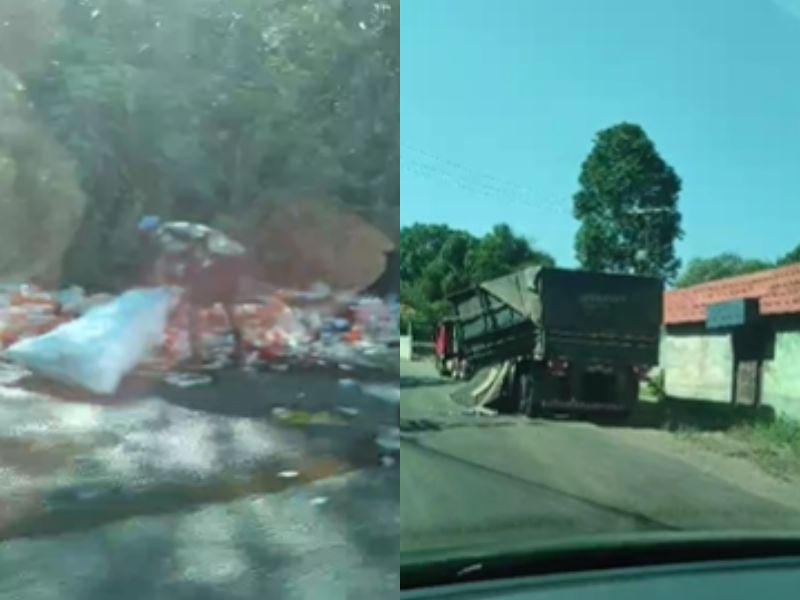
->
[5,289,174,394]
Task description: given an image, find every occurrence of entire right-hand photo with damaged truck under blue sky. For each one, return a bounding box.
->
[399,0,800,600]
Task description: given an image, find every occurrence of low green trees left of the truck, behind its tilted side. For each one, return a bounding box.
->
[400,224,555,328]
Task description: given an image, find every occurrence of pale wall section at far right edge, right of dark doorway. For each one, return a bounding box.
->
[761,331,800,419]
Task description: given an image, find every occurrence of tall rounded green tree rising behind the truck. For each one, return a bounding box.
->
[573,123,683,281]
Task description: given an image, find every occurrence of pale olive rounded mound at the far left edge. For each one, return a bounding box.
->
[0,67,86,282]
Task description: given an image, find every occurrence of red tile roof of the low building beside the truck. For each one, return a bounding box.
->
[664,265,800,325]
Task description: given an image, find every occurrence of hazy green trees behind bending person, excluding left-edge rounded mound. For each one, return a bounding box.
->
[16,0,400,284]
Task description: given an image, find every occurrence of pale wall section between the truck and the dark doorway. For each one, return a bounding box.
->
[661,331,733,402]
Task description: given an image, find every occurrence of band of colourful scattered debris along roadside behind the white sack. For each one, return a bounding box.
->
[0,285,399,399]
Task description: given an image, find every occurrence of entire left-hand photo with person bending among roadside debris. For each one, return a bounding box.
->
[0,0,400,600]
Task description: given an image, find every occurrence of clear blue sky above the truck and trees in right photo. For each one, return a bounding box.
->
[400,0,800,265]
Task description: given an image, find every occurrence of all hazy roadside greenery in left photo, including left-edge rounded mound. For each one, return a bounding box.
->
[0,0,400,290]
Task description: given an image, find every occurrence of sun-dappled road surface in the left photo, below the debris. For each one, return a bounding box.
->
[0,369,399,600]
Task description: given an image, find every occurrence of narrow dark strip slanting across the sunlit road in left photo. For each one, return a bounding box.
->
[0,458,356,541]
